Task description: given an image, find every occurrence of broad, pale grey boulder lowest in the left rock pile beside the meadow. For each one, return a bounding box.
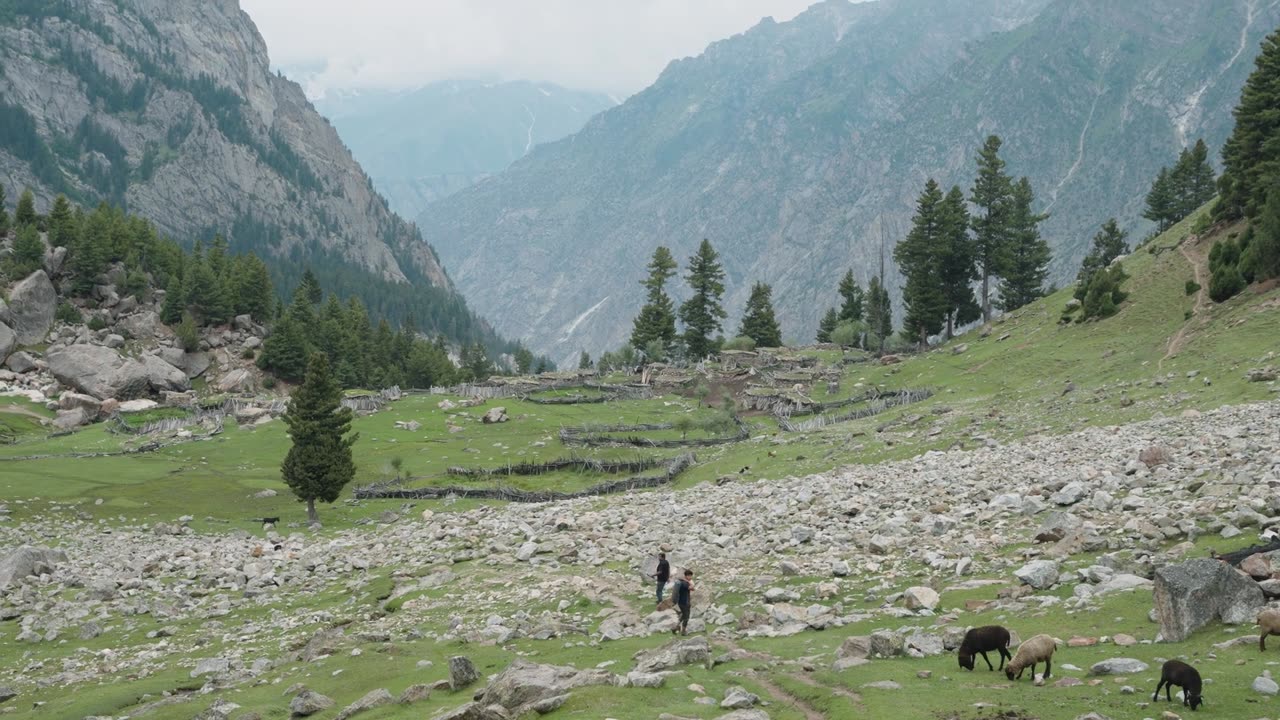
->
[45,345,191,400]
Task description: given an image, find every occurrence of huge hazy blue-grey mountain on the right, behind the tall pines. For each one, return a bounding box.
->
[419,0,1280,361]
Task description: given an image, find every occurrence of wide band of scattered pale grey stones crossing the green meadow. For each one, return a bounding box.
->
[0,402,1280,712]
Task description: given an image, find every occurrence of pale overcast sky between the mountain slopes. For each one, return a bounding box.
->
[241,0,815,96]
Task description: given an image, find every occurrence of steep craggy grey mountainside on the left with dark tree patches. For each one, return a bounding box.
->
[0,0,493,341]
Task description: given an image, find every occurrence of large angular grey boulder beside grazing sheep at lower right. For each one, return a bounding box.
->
[1155,557,1266,642]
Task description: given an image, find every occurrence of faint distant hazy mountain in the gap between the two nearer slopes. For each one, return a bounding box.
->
[315,81,617,218]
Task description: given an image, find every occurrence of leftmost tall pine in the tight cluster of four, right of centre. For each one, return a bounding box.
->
[893,178,948,347]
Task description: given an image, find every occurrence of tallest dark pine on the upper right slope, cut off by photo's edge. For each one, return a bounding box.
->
[1215,31,1280,219]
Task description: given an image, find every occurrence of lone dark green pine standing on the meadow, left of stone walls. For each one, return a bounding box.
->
[280,352,360,525]
